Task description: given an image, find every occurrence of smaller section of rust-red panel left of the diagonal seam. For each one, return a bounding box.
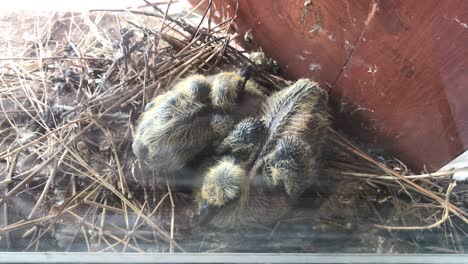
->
[201,0,371,84]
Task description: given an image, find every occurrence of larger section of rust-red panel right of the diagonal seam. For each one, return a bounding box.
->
[334,0,468,169]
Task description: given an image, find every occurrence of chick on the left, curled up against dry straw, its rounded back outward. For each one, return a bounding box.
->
[132,69,265,175]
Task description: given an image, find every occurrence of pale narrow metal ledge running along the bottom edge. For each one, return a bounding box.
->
[0,252,468,264]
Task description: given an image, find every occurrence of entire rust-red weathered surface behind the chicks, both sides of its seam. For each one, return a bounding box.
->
[191,0,468,169]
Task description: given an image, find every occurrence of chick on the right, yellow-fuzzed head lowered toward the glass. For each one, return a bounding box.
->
[196,79,329,228]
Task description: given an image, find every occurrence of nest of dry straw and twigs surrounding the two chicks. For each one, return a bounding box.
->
[0,4,468,253]
